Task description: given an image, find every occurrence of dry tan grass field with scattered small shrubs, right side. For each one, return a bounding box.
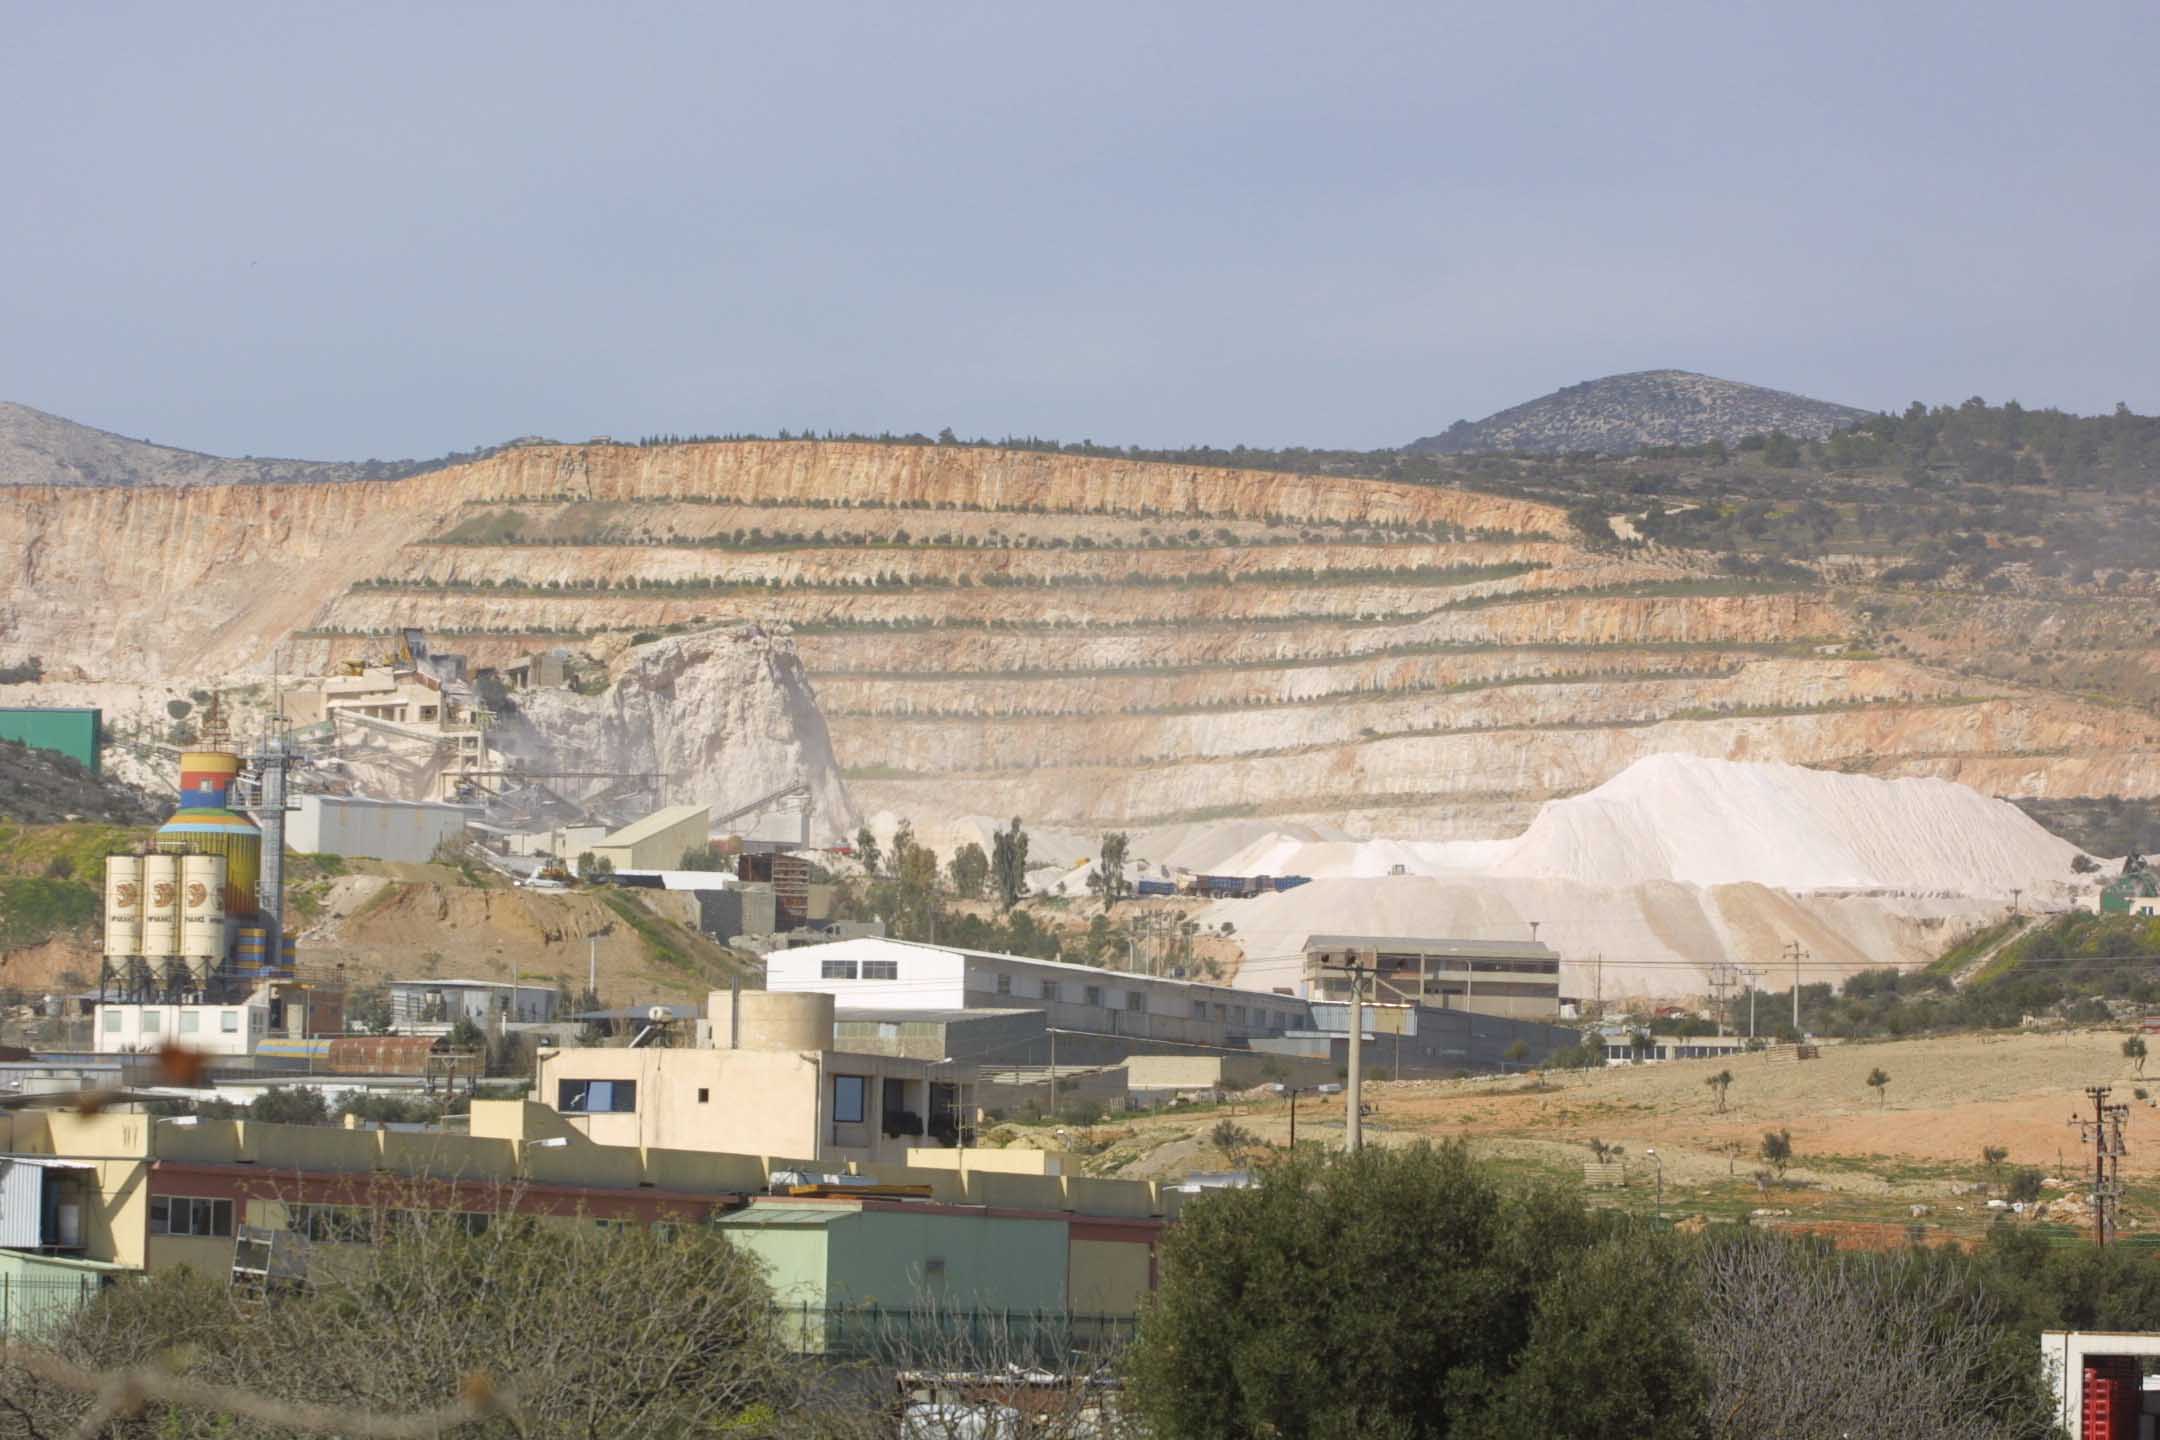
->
[1023,1030,2160,1237]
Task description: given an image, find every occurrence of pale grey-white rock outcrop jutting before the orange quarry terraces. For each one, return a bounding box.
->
[499,626,855,840]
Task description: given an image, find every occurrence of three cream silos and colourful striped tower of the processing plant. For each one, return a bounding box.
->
[97,736,292,1004]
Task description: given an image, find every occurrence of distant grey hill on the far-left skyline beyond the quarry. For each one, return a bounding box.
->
[0,402,495,486]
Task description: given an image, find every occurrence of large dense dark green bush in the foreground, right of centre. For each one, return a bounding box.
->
[1128,1144,1702,1440]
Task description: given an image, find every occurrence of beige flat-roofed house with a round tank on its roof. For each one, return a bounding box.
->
[534,991,974,1166]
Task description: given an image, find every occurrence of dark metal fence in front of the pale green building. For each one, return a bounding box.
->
[773,1302,1138,1371]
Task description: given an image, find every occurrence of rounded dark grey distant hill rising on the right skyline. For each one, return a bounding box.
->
[1410,369,1868,456]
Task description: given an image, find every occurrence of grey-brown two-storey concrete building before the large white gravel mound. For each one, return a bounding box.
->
[1300,935,1560,1021]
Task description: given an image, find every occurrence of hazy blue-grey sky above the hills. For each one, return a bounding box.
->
[0,0,2160,458]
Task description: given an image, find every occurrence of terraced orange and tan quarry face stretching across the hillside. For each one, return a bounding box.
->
[0,440,2160,838]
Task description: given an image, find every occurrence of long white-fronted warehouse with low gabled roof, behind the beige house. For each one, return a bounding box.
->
[765,937,1311,1045]
